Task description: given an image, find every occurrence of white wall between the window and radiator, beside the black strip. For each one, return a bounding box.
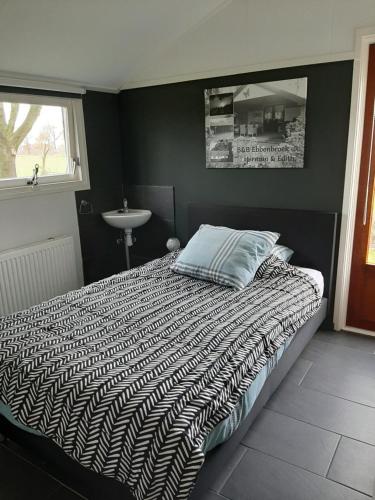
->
[0,192,83,283]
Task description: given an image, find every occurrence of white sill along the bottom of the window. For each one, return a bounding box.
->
[0,179,90,200]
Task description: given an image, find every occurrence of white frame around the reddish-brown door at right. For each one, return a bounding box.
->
[333,26,375,336]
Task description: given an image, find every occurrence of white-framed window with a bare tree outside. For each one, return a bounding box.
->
[0,93,90,198]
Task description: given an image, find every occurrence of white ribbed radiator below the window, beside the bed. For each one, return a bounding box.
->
[0,236,79,316]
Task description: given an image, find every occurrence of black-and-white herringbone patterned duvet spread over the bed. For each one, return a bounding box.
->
[0,254,320,500]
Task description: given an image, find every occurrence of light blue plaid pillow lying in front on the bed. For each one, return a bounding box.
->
[171,224,280,290]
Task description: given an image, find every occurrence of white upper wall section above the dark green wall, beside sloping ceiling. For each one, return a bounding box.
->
[124,0,375,88]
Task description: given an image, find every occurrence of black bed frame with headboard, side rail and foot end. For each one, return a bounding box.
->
[0,204,338,500]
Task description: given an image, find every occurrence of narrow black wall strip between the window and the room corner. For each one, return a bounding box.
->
[76,91,125,283]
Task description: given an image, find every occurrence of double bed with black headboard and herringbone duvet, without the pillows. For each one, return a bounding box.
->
[0,205,337,500]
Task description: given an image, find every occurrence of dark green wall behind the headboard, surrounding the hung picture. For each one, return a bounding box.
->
[120,61,353,239]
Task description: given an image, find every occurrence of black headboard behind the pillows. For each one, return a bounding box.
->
[188,203,338,320]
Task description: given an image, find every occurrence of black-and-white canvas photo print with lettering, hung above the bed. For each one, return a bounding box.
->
[204,78,307,168]
